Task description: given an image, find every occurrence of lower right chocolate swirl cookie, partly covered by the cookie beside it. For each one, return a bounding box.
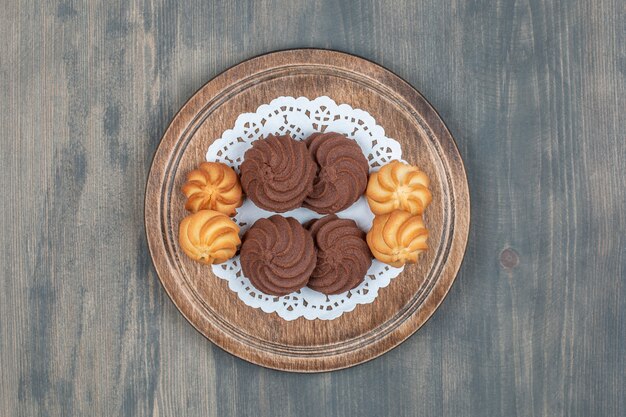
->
[308,215,372,295]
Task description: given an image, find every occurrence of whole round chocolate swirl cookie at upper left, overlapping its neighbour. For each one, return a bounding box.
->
[241,135,316,213]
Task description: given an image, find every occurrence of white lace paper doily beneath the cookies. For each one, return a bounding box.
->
[206,96,402,320]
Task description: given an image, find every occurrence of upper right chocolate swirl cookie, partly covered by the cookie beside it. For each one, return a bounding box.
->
[304,133,369,214]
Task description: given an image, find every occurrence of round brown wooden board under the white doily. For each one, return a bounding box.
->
[145,49,470,372]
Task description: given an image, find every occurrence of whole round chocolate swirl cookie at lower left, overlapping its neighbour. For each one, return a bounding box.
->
[240,214,316,296]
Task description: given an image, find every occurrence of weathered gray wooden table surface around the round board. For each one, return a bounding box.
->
[0,0,626,417]
